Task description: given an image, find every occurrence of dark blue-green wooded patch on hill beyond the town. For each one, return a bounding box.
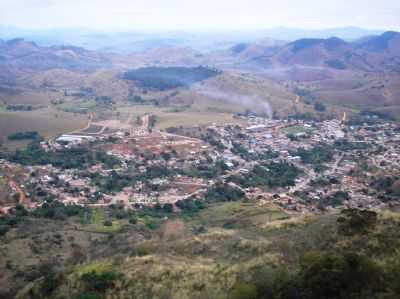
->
[124,66,220,90]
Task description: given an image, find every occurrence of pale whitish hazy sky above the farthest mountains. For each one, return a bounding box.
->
[0,0,400,30]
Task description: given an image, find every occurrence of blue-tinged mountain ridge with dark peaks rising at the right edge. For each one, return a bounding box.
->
[230,31,400,72]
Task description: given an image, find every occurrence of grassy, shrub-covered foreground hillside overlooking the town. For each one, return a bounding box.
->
[0,201,400,299]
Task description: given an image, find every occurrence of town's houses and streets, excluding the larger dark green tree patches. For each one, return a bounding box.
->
[0,116,400,212]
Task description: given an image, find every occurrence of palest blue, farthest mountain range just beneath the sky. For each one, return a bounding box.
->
[0,27,383,53]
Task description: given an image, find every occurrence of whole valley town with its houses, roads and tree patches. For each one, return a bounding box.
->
[0,110,400,214]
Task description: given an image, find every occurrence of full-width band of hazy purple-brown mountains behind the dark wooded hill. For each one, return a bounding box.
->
[0,31,400,82]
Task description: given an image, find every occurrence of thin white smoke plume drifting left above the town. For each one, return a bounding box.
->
[193,85,272,118]
